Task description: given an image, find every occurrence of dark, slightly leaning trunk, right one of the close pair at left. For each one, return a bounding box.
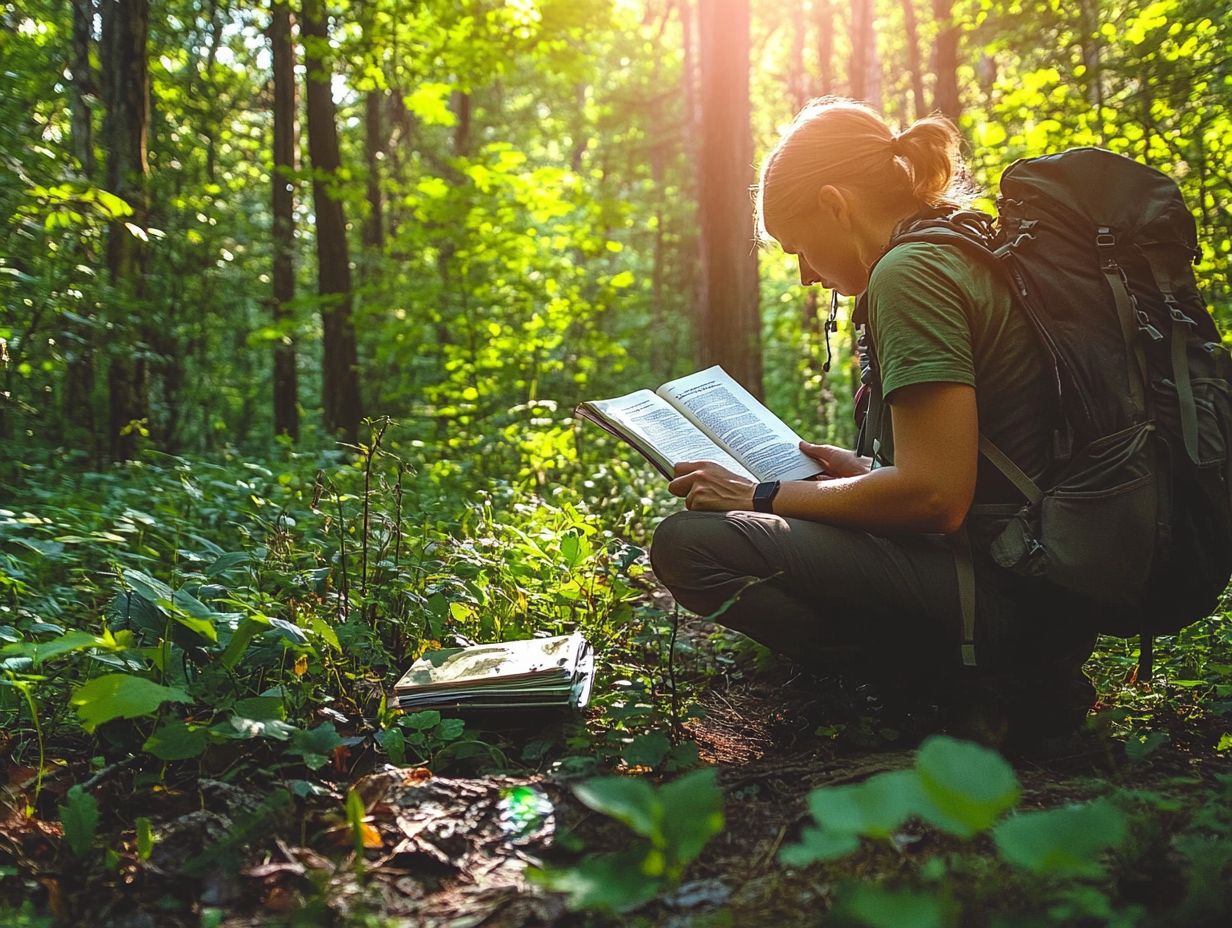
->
[302,0,362,442]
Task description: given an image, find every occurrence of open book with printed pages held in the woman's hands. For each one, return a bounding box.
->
[574,365,822,481]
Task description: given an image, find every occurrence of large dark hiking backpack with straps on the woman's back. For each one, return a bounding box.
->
[860,148,1232,673]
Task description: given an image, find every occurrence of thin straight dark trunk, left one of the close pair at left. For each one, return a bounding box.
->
[270,0,299,440]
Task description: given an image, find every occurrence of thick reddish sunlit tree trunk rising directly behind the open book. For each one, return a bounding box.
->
[697,0,761,397]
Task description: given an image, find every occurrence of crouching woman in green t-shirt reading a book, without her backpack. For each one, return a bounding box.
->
[650,100,1094,738]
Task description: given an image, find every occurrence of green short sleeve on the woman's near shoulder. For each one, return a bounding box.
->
[869,242,976,402]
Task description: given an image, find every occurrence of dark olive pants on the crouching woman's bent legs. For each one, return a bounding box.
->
[650,511,1095,677]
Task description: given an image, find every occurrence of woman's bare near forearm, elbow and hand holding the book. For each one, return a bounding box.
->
[669,383,979,534]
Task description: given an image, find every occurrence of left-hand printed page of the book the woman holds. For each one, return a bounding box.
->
[582,389,754,479]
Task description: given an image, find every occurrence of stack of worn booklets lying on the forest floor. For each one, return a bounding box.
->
[391,633,595,712]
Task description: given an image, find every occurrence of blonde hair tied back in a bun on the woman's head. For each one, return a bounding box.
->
[756,97,962,243]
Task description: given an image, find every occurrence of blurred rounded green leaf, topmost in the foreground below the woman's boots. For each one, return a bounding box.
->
[915,735,1019,838]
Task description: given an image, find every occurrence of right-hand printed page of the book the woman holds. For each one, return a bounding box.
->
[659,365,822,481]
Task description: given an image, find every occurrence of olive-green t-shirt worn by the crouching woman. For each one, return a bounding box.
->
[869,242,1056,503]
